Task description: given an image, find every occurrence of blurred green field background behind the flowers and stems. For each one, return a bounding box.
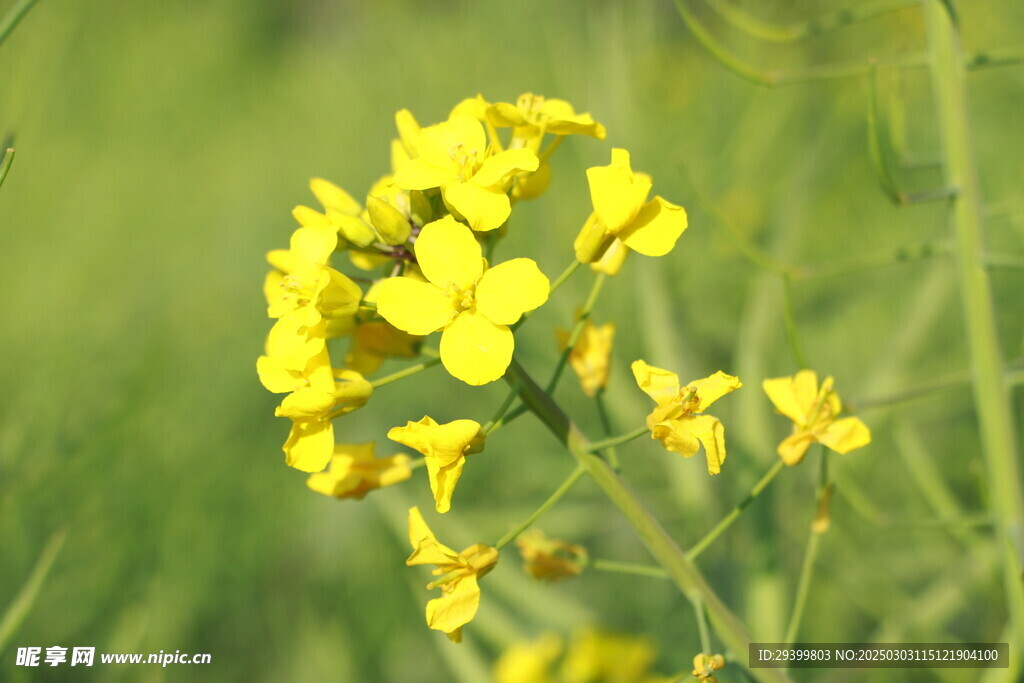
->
[0,0,1024,681]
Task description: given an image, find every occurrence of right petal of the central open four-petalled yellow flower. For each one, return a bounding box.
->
[476,258,551,325]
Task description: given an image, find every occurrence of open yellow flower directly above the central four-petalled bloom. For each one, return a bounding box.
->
[395,114,540,230]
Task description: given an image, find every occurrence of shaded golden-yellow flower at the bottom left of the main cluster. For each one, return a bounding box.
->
[306,441,413,500]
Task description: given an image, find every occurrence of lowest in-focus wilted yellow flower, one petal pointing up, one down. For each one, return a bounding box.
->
[406,508,498,643]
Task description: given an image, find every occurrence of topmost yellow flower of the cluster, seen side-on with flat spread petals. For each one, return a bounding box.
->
[486,92,605,140]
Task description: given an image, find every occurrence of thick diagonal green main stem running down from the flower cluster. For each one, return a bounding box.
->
[505,358,791,681]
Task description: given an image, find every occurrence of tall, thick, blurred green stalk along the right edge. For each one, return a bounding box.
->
[922,0,1024,680]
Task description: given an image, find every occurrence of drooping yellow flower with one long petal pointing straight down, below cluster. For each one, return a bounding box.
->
[387,416,485,513]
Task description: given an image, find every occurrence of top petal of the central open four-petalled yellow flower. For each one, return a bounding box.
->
[411,216,483,290]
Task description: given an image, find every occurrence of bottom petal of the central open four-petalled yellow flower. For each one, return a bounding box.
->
[440,310,515,386]
